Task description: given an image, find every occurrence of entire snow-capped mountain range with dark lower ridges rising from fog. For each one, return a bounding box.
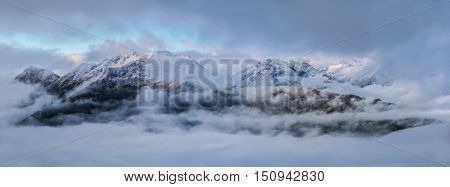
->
[15,51,433,135]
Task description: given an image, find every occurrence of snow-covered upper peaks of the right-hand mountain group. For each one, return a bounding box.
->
[238,59,390,88]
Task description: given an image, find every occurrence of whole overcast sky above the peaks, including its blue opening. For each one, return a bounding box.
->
[0,0,450,77]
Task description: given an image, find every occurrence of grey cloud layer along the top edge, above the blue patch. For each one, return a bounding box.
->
[1,0,450,53]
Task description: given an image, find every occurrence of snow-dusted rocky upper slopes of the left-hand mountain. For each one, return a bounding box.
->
[16,51,211,99]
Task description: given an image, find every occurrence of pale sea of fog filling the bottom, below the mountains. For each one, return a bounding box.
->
[0,76,450,166]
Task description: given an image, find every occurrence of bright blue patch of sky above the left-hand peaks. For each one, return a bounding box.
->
[0,22,221,53]
